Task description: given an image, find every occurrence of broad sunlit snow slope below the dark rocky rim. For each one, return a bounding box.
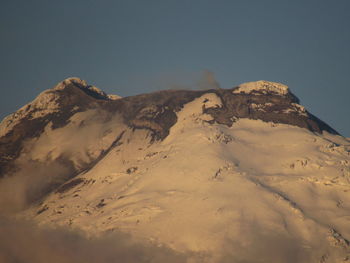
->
[21,93,350,262]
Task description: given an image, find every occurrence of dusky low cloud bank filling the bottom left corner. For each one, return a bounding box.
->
[0,218,186,263]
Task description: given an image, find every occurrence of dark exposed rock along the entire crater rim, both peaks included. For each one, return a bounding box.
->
[0,78,337,180]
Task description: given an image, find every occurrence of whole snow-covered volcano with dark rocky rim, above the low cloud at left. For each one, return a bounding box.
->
[0,78,350,262]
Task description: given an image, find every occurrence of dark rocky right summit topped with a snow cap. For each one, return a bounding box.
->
[206,81,338,134]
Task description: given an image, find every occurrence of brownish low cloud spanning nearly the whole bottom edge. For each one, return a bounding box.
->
[0,217,336,263]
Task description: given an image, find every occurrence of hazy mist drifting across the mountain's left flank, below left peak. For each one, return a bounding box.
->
[0,110,124,214]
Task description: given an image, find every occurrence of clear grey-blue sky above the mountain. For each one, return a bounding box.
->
[0,0,350,137]
